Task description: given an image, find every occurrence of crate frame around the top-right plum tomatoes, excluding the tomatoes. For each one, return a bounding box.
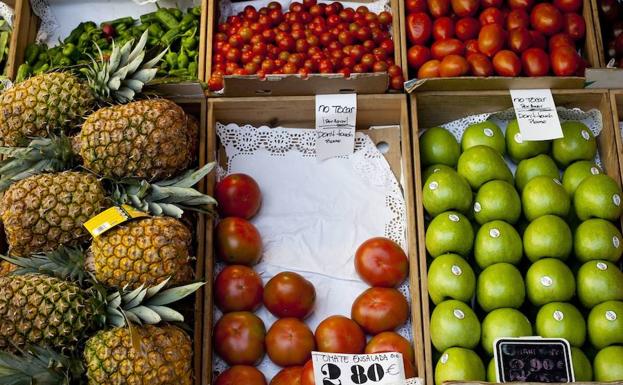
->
[400,0,600,92]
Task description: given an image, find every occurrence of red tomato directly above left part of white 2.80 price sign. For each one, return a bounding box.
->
[316,315,366,354]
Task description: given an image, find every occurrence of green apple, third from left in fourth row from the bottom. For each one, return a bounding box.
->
[523,215,573,262]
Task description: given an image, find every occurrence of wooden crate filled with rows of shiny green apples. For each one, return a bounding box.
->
[411,90,623,385]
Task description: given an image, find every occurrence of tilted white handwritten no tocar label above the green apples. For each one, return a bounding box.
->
[510,89,563,141]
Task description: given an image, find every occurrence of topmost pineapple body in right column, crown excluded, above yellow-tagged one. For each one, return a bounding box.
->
[80,99,196,180]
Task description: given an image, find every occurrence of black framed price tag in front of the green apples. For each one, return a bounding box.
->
[494,337,575,382]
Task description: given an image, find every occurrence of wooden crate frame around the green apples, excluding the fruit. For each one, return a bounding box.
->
[410,90,623,385]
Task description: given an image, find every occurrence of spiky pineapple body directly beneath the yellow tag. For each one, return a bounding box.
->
[89,217,192,288]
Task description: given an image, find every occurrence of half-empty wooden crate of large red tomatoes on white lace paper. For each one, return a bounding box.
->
[203,94,425,385]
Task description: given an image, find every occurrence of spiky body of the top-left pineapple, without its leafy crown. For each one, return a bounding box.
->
[0,72,95,146]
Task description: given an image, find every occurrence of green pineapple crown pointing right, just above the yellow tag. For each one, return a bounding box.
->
[111,162,217,218]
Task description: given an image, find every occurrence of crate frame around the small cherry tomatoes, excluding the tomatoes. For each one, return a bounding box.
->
[204,0,406,97]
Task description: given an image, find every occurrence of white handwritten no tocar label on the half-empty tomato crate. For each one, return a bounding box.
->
[316,94,357,160]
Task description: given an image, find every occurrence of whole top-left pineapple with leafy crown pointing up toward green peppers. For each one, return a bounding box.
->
[0,31,165,146]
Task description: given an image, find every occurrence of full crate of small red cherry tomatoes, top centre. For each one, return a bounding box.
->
[205,0,406,96]
